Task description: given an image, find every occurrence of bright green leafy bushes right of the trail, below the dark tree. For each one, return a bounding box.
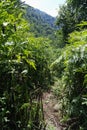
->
[53,25,87,130]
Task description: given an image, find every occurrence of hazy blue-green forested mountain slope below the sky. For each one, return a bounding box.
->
[26,5,56,39]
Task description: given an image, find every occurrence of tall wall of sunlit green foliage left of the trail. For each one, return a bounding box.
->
[0,0,53,130]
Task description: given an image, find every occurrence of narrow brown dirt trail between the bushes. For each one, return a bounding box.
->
[43,92,63,130]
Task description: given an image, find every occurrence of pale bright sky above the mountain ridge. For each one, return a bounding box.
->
[22,0,66,17]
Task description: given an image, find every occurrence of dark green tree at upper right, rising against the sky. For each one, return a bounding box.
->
[57,0,87,46]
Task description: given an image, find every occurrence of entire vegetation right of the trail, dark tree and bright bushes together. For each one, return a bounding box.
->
[52,0,87,130]
